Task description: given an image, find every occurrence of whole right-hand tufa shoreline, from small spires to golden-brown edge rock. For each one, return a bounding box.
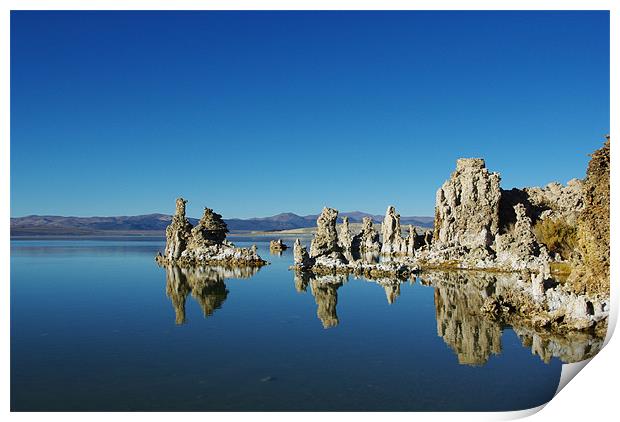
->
[293,138,610,333]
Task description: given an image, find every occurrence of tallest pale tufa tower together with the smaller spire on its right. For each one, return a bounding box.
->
[419,158,550,271]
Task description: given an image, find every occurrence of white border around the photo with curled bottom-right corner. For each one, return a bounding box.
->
[0,0,620,421]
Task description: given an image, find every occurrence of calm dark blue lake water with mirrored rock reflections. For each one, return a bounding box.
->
[11,239,562,411]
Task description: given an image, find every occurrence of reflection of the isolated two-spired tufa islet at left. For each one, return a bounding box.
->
[165,265,259,325]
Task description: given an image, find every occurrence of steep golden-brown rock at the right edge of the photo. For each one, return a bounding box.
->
[570,136,610,297]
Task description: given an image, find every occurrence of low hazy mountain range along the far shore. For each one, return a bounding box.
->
[11,211,433,236]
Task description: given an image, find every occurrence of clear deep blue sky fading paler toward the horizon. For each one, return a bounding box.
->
[11,11,609,218]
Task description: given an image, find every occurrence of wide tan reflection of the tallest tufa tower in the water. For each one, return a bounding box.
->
[432,273,502,366]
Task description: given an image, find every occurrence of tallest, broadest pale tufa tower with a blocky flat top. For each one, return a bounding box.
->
[433,158,501,252]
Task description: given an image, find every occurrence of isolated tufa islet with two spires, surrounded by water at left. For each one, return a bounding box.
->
[156,198,267,267]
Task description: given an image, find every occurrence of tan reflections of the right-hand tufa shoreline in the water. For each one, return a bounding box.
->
[294,271,603,366]
